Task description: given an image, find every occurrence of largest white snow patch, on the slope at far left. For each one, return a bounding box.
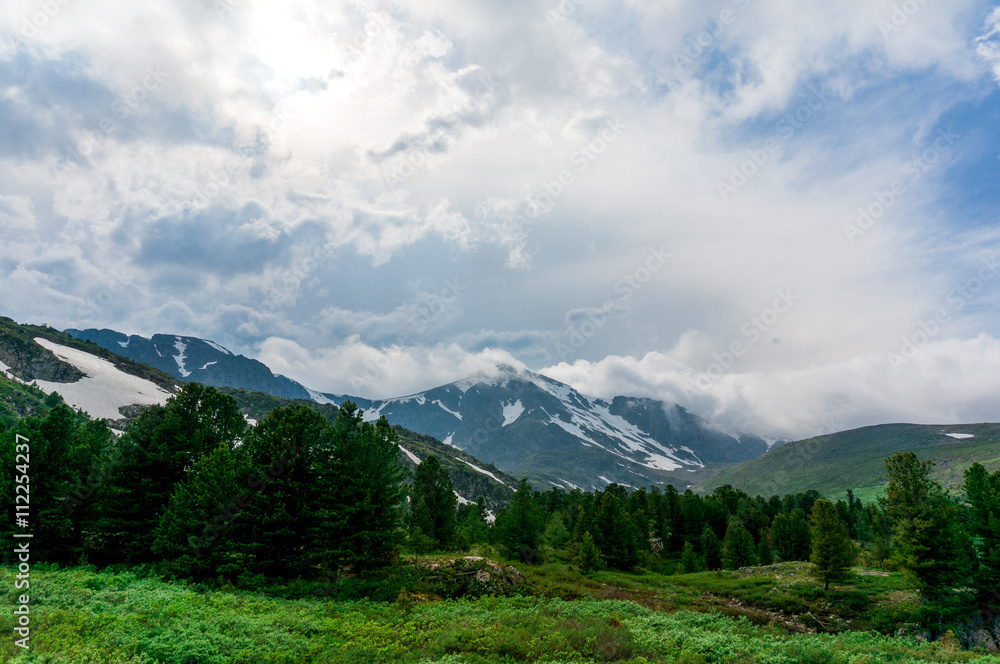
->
[34,337,173,420]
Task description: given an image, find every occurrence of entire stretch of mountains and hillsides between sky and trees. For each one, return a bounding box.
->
[0,317,1000,500]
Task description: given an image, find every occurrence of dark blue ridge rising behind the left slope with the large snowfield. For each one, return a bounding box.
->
[66,329,312,399]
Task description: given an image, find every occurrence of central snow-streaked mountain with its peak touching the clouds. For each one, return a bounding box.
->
[322,365,767,490]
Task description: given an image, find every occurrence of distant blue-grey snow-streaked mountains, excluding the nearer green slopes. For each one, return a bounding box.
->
[66,329,768,490]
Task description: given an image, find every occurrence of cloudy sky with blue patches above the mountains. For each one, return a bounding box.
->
[0,0,1000,438]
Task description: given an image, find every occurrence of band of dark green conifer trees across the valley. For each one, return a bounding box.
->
[0,383,1000,621]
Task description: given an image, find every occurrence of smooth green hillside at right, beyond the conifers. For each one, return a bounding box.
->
[693,424,1000,500]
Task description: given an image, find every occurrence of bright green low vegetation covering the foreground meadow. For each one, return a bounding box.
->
[0,565,1000,664]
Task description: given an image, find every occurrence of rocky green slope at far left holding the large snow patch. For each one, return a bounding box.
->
[0,317,180,426]
